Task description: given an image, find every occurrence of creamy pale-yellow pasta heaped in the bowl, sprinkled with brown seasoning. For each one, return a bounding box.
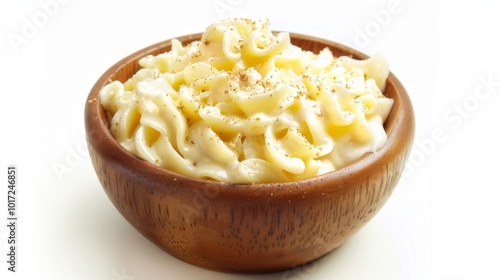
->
[100,19,393,183]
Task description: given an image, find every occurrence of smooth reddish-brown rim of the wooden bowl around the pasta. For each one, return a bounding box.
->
[84,31,415,197]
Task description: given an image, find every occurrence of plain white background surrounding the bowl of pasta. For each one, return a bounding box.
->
[0,0,500,280]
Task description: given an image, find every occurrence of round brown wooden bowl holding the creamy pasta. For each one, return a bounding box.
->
[85,31,415,273]
